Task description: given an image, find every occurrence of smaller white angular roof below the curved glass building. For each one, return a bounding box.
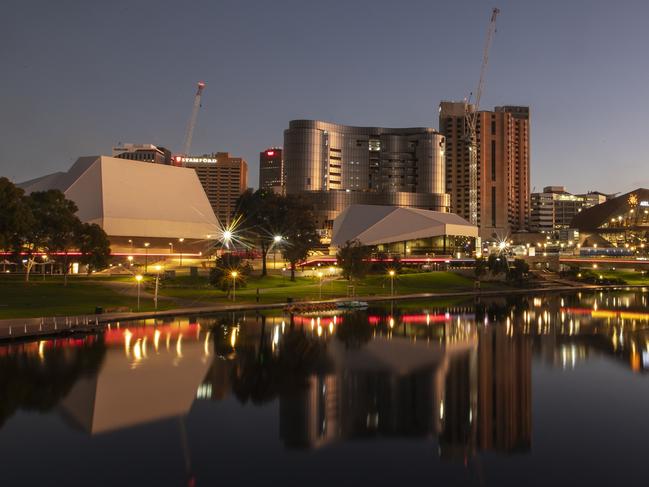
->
[331,205,478,247]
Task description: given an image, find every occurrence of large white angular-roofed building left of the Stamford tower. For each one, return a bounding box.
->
[20,156,219,239]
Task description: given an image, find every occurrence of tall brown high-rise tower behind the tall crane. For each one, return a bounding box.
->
[439,101,530,238]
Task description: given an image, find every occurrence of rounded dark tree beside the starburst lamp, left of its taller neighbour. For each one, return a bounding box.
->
[237,189,286,276]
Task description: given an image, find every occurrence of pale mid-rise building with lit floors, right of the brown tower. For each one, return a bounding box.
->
[530,186,607,234]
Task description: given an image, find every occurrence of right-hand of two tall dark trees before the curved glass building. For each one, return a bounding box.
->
[282,196,318,281]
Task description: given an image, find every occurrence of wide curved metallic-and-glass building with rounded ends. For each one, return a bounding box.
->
[284,120,449,242]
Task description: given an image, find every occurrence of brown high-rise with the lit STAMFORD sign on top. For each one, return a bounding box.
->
[174,152,248,225]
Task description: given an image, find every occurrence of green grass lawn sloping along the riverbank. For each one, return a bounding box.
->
[0,272,499,319]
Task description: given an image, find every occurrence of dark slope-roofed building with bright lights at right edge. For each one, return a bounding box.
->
[571,188,649,253]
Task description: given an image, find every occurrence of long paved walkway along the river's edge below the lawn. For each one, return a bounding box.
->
[0,283,647,340]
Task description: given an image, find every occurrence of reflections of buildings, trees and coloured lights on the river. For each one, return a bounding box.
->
[0,292,649,468]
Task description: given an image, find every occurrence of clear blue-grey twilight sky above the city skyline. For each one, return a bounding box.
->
[0,0,649,192]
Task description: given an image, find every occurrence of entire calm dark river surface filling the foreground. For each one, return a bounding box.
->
[0,292,649,486]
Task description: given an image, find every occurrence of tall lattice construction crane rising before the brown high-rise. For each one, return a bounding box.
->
[464,8,500,225]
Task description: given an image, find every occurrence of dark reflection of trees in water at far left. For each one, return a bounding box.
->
[0,337,106,426]
